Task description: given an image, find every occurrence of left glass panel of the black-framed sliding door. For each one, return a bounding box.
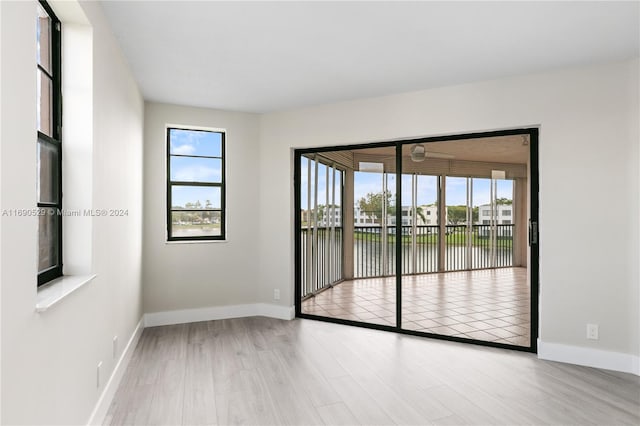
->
[300,146,396,326]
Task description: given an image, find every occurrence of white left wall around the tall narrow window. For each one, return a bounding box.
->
[0,1,144,424]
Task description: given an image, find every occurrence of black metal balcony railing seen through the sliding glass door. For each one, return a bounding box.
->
[300,225,514,297]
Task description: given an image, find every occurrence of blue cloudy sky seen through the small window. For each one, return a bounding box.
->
[169,129,222,208]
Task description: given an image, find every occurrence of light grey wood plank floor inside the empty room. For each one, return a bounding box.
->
[104,317,640,425]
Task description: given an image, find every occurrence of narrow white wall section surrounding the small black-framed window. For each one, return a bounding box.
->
[143,103,260,313]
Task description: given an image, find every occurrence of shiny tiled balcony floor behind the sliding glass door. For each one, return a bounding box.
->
[302,268,531,346]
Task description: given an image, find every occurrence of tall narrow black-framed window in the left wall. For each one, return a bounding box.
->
[36,1,62,286]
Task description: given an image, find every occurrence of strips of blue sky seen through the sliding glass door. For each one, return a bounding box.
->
[300,158,513,209]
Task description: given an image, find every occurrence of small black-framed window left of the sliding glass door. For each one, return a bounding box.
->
[167,128,225,241]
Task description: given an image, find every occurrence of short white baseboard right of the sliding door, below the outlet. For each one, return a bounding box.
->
[538,340,640,376]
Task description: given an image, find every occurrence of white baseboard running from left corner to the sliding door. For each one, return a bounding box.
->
[144,303,295,327]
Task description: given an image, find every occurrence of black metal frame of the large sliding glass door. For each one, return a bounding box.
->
[293,127,540,353]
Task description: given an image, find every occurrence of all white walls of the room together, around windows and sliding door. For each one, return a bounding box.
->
[0,2,640,424]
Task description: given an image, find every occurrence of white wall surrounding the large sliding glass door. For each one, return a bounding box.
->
[259,60,640,362]
